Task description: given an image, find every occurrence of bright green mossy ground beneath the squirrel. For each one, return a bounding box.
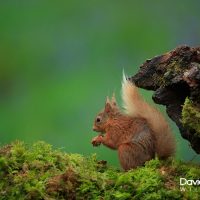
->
[0,142,200,200]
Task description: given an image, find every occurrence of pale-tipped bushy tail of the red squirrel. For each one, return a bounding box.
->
[122,75,175,158]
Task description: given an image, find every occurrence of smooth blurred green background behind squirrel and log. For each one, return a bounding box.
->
[0,0,200,166]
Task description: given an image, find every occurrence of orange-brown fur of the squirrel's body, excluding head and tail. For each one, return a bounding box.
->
[92,103,155,170]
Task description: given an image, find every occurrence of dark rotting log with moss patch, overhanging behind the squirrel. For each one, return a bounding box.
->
[131,46,200,153]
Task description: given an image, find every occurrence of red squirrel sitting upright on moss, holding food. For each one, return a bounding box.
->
[92,75,175,171]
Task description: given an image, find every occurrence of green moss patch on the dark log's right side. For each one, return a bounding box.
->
[182,98,200,137]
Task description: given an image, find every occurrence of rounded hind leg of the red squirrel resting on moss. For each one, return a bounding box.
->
[118,143,154,171]
